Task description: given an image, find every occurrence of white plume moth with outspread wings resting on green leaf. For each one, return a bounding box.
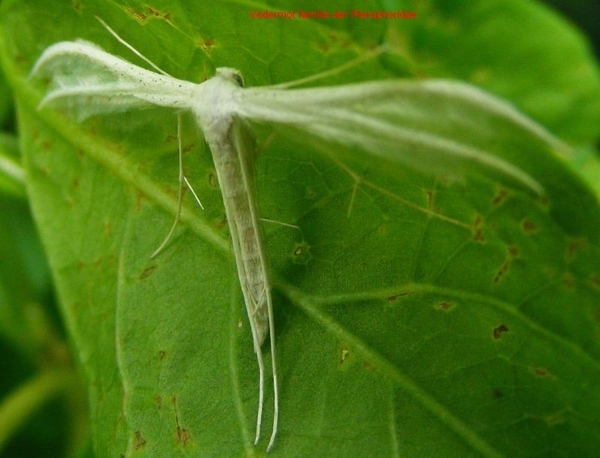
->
[32,17,543,450]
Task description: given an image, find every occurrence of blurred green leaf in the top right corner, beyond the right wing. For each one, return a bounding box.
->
[392,0,600,143]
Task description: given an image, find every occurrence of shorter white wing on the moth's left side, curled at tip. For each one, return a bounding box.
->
[31,40,198,119]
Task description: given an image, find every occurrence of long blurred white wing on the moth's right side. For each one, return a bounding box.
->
[238,80,557,194]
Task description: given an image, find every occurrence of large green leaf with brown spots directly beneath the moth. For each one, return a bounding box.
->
[0,1,600,457]
